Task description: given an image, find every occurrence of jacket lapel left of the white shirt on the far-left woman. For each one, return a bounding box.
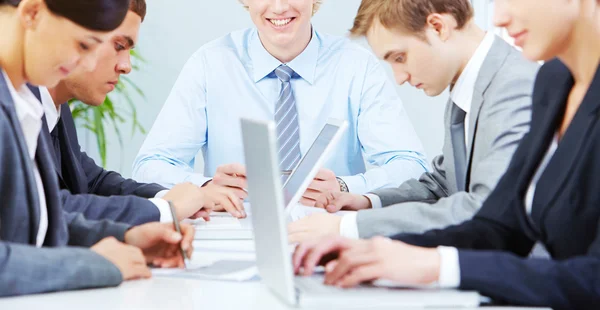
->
[0,68,40,244]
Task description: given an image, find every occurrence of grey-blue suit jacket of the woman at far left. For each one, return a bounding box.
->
[0,68,129,296]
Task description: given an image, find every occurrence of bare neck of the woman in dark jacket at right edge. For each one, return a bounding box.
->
[558,13,600,85]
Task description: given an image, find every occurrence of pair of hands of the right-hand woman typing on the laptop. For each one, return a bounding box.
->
[293,237,441,287]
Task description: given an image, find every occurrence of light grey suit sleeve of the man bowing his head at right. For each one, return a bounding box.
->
[357,66,534,237]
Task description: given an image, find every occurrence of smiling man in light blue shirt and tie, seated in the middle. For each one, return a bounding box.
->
[133,0,428,217]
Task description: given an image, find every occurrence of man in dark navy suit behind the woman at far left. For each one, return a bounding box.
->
[32,0,241,224]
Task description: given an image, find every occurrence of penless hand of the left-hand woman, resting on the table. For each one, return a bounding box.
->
[90,237,152,281]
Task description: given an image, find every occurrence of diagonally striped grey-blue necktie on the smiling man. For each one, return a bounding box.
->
[275,65,301,170]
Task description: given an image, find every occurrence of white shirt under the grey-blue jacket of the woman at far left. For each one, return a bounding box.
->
[2,70,48,247]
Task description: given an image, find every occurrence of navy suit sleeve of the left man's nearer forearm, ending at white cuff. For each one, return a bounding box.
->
[60,190,160,225]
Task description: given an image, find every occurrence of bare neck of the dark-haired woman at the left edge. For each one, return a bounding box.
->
[0,6,27,89]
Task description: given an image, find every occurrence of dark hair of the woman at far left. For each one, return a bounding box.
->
[0,0,130,31]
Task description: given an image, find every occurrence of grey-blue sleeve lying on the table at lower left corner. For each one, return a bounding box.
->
[0,241,123,297]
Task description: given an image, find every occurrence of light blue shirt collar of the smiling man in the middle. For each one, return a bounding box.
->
[249,30,320,85]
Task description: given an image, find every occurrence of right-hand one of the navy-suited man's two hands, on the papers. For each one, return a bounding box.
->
[195,184,246,219]
